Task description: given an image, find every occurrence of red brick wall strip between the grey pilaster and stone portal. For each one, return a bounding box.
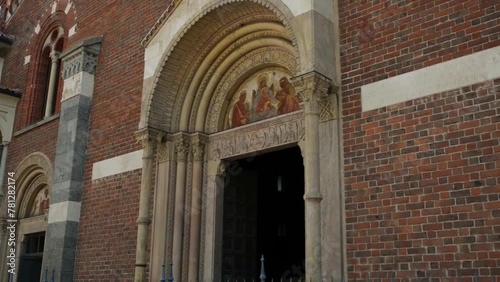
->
[72,0,168,281]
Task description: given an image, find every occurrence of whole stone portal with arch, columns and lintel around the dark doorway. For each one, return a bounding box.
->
[135,0,337,281]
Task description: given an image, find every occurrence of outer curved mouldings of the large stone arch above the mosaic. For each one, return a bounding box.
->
[139,0,300,132]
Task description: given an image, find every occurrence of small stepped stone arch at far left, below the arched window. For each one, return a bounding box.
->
[16,152,53,218]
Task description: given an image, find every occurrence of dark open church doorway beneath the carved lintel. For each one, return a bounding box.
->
[222,147,305,281]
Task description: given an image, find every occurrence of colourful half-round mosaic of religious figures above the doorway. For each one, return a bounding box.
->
[226,70,300,128]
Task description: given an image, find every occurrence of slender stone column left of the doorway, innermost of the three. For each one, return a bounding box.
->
[188,134,205,282]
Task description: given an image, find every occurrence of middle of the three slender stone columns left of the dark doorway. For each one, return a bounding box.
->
[172,133,189,281]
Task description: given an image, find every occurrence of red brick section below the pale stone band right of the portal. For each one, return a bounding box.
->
[344,80,500,278]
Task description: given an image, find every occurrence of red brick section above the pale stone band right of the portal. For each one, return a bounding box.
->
[339,0,500,116]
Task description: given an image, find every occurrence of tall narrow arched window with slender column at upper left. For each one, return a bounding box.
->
[31,26,65,123]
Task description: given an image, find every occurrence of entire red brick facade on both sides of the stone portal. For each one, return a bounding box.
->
[2,0,500,281]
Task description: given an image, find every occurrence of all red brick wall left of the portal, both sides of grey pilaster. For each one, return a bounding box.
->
[2,0,169,281]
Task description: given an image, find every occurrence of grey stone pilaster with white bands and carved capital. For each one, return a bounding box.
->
[43,37,102,282]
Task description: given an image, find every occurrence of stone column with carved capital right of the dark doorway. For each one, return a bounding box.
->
[292,72,331,281]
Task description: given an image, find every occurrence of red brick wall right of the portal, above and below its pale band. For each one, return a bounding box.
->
[340,0,500,279]
